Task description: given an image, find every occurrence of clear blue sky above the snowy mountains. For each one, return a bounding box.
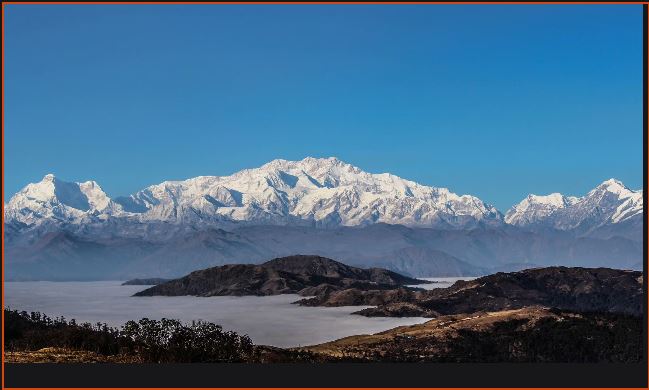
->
[5,4,642,211]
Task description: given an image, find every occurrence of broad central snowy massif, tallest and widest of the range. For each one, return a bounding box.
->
[119,157,501,227]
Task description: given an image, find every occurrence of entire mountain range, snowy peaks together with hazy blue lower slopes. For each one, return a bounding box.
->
[4,158,643,279]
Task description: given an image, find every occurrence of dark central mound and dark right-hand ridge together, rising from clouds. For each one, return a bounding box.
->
[135,256,643,317]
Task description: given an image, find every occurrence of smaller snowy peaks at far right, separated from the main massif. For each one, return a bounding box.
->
[505,179,643,234]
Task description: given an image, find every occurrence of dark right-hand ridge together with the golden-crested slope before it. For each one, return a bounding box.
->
[300,267,644,362]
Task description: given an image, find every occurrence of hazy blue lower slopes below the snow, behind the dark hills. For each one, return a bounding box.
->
[5,224,642,280]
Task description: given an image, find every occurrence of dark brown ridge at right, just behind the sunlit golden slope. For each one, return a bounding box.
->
[299,267,643,317]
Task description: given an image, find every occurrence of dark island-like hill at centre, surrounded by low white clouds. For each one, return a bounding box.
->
[135,255,429,296]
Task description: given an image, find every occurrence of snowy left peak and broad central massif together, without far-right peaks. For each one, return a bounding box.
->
[5,157,502,233]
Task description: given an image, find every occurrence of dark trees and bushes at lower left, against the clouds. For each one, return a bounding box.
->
[4,308,255,363]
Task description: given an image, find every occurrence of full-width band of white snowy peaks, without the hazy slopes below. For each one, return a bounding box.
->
[4,157,643,239]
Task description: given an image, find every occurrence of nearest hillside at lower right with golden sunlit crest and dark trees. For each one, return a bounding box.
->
[299,306,644,363]
